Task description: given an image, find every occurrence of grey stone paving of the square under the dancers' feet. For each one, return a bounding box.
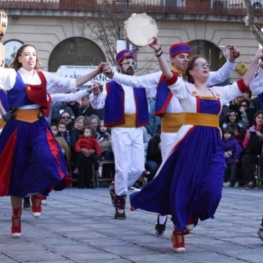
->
[0,187,263,263]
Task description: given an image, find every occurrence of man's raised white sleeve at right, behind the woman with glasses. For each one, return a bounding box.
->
[206,61,235,86]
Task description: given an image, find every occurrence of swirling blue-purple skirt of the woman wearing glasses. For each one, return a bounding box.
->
[130,126,224,230]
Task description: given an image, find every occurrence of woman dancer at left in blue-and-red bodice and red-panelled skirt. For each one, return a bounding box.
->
[0,44,103,237]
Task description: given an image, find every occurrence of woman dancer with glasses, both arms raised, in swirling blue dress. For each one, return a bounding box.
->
[130,38,263,252]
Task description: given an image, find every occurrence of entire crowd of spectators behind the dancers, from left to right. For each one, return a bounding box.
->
[50,83,263,190]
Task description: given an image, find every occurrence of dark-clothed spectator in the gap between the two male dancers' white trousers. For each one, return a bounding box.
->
[145,125,162,182]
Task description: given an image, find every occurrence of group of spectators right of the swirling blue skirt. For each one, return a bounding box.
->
[220,91,263,190]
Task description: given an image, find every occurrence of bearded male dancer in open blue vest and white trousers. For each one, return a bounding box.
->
[101,49,149,219]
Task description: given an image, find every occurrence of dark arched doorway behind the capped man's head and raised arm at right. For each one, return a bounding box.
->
[189,40,226,71]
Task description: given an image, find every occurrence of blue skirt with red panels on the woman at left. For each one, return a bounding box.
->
[0,118,71,197]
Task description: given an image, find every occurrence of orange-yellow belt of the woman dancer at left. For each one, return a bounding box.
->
[10,109,44,123]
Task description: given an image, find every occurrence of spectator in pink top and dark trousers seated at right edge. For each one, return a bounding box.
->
[242,110,263,190]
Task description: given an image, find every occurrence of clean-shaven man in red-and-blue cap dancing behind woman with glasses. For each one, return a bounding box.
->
[103,42,238,235]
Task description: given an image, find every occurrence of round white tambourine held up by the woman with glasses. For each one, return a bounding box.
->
[124,13,159,47]
